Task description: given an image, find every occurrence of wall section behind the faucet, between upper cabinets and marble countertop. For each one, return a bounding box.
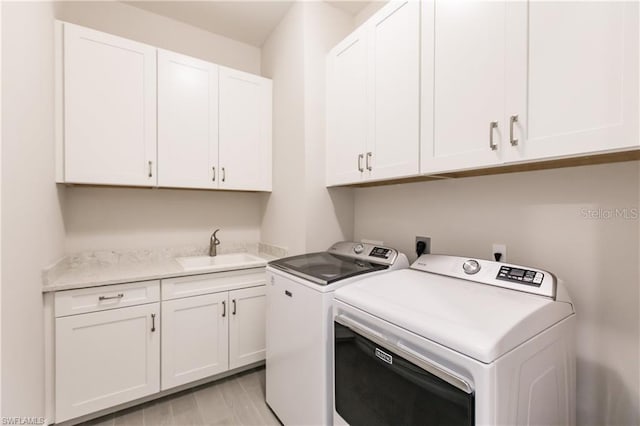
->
[64,186,262,253]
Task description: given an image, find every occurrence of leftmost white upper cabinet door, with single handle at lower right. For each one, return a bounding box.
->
[64,24,156,186]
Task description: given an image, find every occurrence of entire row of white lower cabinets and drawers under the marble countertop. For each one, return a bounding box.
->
[53,268,266,423]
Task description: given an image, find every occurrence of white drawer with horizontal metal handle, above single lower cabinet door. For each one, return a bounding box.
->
[55,280,160,318]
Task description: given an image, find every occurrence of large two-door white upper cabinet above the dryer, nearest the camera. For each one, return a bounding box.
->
[421,0,639,174]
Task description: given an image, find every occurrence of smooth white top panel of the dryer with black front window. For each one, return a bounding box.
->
[335,269,573,363]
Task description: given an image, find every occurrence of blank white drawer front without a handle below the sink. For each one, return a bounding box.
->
[162,268,266,300]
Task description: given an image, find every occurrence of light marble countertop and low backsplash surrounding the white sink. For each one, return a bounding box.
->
[42,244,286,293]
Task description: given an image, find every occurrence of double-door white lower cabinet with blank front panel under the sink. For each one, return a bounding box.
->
[162,269,266,390]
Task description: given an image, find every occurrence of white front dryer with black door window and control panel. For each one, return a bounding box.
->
[334,255,575,426]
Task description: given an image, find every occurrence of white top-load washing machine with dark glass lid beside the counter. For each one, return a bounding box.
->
[266,242,409,425]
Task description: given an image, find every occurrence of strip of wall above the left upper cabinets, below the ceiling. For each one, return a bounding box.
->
[56,0,260,74]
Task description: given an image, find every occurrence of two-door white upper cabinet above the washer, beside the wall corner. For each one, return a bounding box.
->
[326,1,420,185]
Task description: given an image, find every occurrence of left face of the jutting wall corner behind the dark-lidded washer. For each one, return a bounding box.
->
[261,3,306,254]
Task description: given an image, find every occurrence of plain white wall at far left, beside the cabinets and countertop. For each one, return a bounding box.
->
[0,2,64,416]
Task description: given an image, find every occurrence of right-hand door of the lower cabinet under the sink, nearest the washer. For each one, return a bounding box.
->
[229,286,267,368]
